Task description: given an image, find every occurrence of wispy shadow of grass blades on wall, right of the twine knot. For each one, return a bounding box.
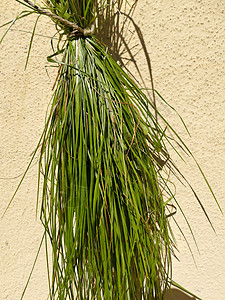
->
[97,0,157,120]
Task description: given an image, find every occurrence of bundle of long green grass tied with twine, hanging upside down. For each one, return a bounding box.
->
[0,0,221,300]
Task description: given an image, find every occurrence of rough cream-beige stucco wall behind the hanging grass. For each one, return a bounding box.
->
[0,0,225,300]
